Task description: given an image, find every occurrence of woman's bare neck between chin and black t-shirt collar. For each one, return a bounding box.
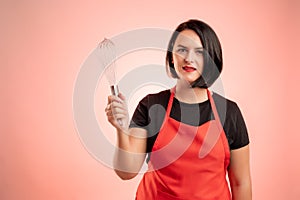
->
[175,81,208,103]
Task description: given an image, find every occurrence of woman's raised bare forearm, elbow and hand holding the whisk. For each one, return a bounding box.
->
[105,94,147,180]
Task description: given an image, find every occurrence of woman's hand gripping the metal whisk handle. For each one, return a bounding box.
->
[105,93,129,132]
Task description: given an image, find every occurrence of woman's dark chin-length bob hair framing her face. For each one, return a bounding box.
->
[166,19,223,88]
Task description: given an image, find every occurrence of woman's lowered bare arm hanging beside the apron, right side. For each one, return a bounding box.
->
[228,145,252,200]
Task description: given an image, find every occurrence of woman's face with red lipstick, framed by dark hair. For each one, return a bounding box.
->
[172,29,204,83]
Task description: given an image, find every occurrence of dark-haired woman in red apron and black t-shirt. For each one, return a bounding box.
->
[106,20,252,200]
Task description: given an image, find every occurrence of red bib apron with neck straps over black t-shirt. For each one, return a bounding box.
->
[136,88,231,200]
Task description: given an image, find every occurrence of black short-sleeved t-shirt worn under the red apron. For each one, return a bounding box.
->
[129,90,249,159]
